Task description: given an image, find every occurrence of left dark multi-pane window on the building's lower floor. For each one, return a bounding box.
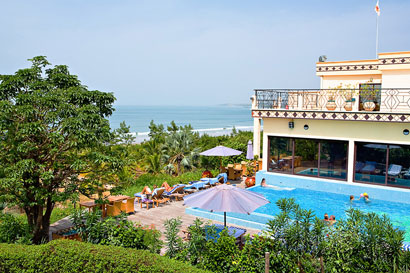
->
[268,137,348,180]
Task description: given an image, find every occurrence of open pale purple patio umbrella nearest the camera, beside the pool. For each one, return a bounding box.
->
[184,184,270,226]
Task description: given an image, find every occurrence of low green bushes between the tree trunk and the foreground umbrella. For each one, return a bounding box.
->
[71,210,162,253]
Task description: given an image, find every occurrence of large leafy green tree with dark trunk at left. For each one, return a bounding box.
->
[0,56,115,244]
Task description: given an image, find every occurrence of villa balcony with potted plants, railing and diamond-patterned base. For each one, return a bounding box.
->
[252,88,410,122]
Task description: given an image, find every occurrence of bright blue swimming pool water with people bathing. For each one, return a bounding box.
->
[223,186,410,242]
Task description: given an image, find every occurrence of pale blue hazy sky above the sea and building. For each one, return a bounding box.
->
[0,0,410,106]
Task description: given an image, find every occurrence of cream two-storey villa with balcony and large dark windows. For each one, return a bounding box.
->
[252,52,410,188]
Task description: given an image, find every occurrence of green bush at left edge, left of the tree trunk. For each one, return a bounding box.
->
[0,213,30,244]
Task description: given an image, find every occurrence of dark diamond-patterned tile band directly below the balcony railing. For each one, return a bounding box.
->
[252,110,410,123]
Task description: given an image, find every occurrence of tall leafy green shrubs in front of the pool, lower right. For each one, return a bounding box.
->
[163,199,410,273]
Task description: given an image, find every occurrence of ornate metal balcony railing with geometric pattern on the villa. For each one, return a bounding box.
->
[253,88,410,113]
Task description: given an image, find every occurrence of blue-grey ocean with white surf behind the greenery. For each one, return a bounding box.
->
[109,104,253,143]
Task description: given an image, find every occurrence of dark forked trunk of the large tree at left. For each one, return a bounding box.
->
[24,197,54,244]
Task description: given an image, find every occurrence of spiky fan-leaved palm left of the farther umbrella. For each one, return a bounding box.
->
[162,130,199,175]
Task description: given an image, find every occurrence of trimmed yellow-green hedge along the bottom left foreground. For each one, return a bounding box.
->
[0,240,208,273]
